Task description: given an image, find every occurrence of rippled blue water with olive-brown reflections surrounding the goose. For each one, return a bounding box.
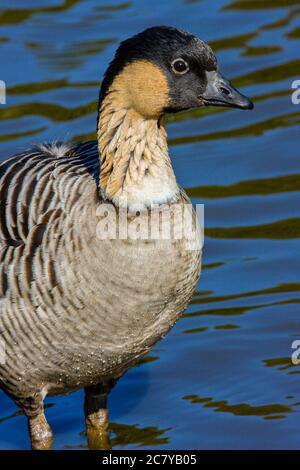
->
[0,0,300,449]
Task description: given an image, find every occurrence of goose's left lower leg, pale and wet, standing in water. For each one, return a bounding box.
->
[28,411,53,450]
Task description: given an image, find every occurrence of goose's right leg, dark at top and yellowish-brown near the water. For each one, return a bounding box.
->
[84,379,116,450]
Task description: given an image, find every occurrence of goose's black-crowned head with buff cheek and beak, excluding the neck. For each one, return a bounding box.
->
[100,26,253,115]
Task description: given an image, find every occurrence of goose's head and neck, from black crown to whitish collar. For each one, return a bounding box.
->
[97,26,253,210]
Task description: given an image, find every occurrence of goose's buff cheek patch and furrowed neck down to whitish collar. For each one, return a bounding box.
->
[98,61,179,210]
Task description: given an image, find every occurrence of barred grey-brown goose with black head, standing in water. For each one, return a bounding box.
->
[0,26,253,450]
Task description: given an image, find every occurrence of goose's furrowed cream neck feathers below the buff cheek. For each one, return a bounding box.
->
[98,87,179,210]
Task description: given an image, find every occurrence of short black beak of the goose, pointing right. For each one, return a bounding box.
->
[202,71,254,109]
